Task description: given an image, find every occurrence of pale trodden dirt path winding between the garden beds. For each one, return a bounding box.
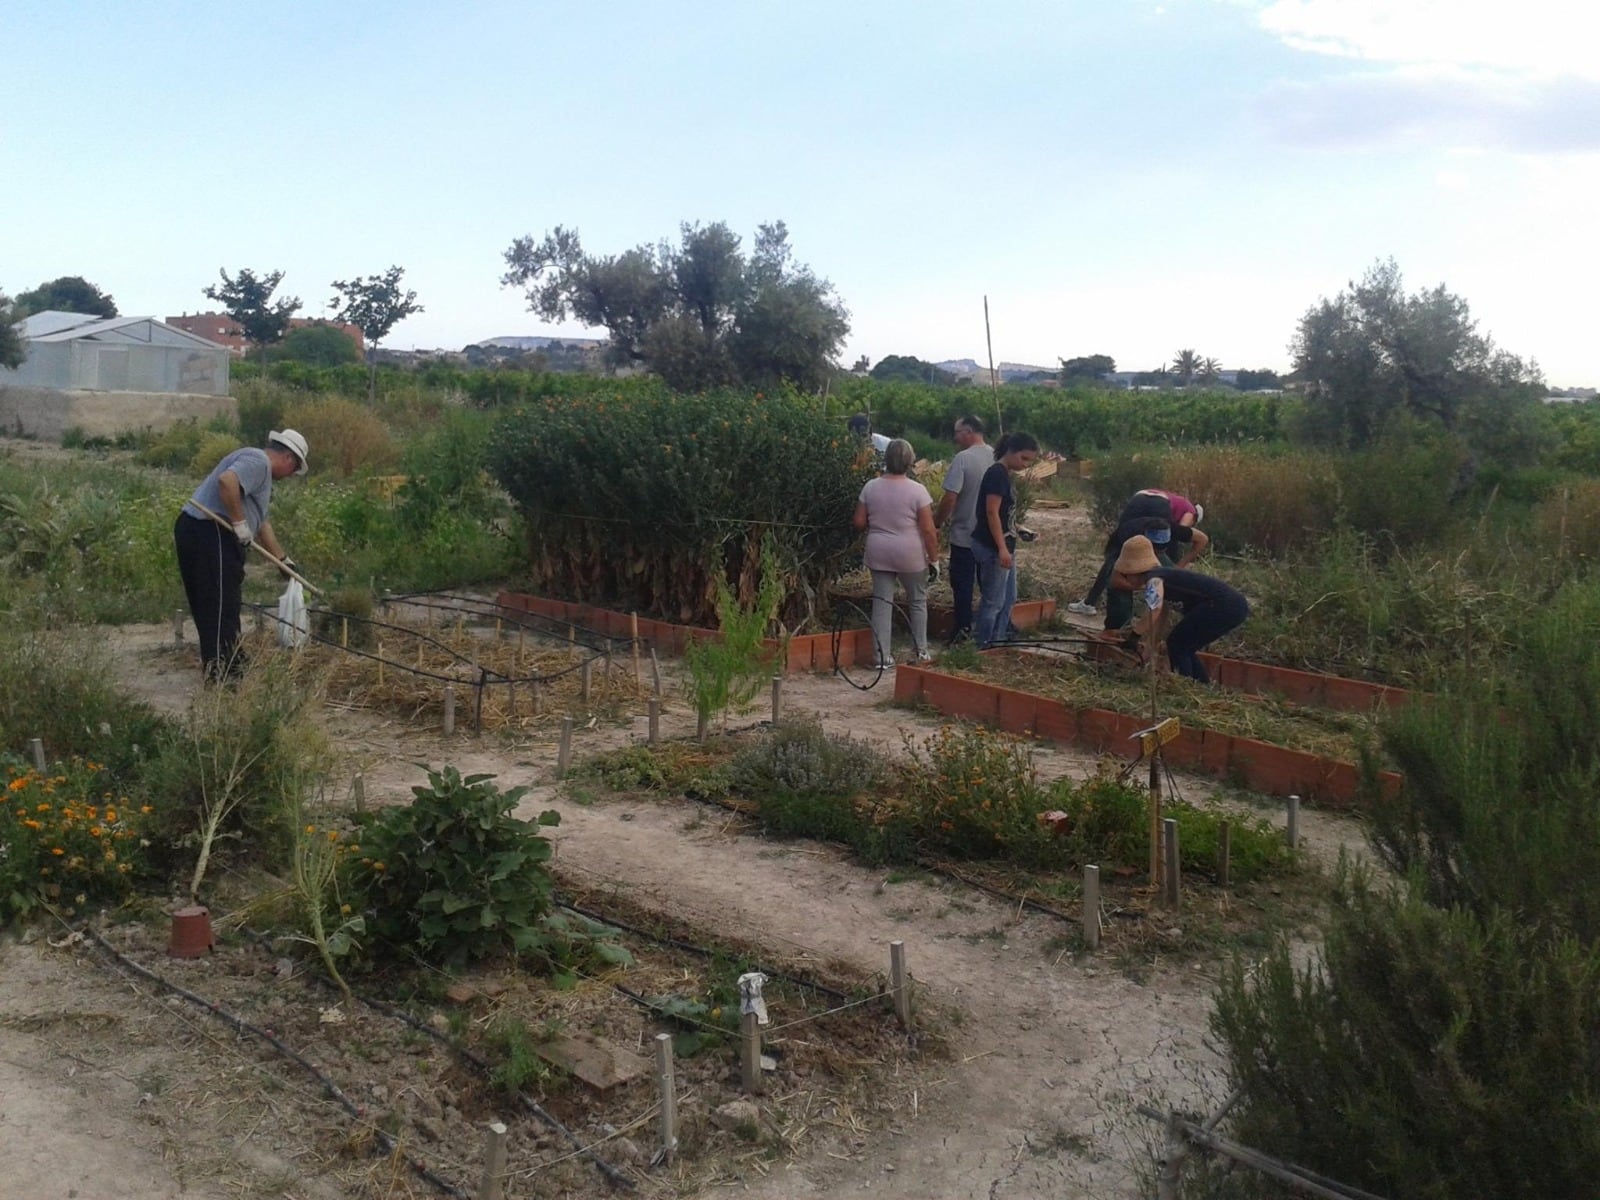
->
[0,626,1360,1200]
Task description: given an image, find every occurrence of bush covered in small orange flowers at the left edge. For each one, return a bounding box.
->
[0,755,152,923]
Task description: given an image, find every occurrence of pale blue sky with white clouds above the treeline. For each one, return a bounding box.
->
[0,0,1600,386]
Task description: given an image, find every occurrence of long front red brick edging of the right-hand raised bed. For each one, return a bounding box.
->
[894,667,1400,808]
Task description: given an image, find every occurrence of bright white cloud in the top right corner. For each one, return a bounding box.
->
[1258,0,1600,78]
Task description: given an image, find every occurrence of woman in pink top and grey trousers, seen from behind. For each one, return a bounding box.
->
[854,437,939,670]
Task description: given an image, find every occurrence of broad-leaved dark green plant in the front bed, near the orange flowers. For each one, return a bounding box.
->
[355,766,562,966]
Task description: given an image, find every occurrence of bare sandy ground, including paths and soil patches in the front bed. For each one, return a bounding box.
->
[0,537,1360,1200]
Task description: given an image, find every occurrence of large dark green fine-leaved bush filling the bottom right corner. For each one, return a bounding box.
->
[1213,586,1600,1200]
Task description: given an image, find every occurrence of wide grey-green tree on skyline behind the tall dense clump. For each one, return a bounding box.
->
[501,221,850,390]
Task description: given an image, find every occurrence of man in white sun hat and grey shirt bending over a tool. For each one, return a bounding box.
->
[173,429,309,680]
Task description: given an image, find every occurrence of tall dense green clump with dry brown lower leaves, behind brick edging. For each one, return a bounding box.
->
[488,392,866,626]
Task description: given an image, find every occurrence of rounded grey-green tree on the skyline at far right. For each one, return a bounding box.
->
[1290,259,1544,450]
